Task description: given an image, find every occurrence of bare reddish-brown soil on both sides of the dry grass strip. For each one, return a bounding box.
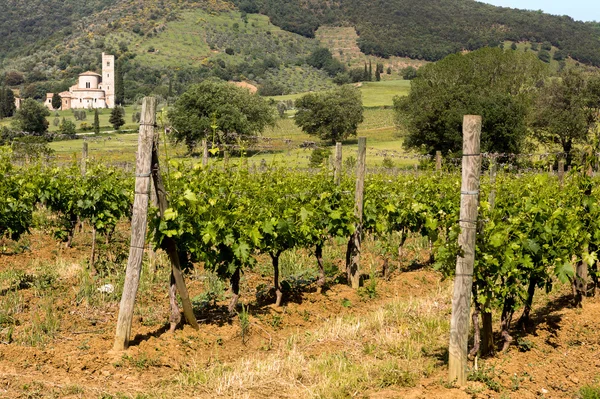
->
[0,232,600,398]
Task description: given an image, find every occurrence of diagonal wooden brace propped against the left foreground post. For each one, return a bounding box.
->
[152,140,199,331]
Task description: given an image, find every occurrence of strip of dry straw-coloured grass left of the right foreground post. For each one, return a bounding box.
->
[172,284,450,398]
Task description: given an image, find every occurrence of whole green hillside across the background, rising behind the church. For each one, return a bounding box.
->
[0,0,600,103]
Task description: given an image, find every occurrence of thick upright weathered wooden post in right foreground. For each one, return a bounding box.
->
[448,115,481,386]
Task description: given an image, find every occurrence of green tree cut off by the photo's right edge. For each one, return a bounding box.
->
[531,69,600,164]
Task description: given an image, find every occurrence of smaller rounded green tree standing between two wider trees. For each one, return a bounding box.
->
[295,86,363,143]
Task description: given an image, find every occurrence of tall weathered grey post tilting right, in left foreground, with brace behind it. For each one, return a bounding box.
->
[113,97,156,351]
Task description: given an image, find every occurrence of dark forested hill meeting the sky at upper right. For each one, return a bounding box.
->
[234,0,600,66]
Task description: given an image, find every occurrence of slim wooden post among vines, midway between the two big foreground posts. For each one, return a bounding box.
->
[346,137,367,289]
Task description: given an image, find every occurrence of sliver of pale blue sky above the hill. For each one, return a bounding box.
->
[480,0,600,22]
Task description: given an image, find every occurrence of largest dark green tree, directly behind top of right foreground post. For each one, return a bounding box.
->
[394,47,547,154]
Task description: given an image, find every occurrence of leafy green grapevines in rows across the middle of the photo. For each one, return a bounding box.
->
[0,147,600,352]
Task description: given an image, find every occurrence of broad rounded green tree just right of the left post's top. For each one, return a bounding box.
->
[168,80,275,152]
